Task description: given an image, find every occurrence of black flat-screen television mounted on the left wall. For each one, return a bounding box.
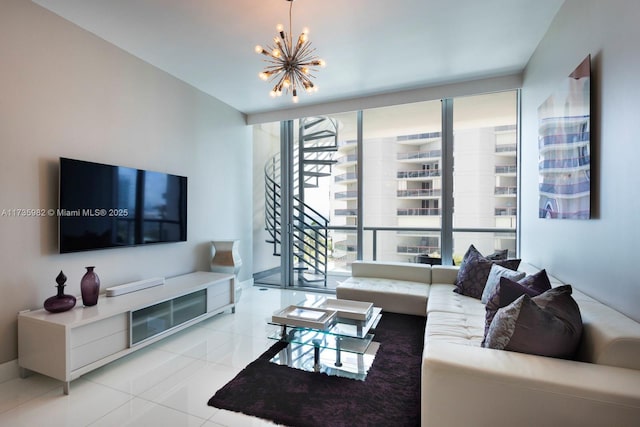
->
[57,157,187,253]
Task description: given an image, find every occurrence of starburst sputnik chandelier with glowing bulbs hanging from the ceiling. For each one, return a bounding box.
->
[255,0,325,102]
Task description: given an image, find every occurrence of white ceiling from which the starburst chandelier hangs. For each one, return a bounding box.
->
[33,0,564,114]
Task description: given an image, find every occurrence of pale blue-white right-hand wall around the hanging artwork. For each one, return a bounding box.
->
[520,0,640,320]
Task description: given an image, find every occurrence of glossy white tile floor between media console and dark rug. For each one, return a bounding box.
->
[0,286,326,427]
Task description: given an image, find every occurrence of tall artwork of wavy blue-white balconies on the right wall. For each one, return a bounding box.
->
[538,55,591,219]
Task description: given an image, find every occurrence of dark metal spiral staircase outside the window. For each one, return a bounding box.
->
[264,117,338,287]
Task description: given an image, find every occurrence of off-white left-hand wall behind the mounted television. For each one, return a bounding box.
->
[0,0,252,364]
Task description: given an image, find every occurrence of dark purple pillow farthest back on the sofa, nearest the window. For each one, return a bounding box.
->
[453,245,520,299]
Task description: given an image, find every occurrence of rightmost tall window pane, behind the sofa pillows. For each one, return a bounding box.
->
[453,91,518,261]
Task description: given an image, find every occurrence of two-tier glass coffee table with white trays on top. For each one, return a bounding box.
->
[268,297,382,380]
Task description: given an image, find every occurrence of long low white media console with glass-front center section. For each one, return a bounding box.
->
[18,272,235,394]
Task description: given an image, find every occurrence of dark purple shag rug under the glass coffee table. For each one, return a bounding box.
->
[208,313,426,427]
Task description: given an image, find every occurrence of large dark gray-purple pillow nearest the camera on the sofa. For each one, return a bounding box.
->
[484,285,582,359]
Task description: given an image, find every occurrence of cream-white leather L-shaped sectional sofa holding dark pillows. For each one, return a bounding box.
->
[336,261,640,427]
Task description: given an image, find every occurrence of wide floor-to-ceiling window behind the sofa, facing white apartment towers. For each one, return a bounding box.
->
[252,91,518,290]
